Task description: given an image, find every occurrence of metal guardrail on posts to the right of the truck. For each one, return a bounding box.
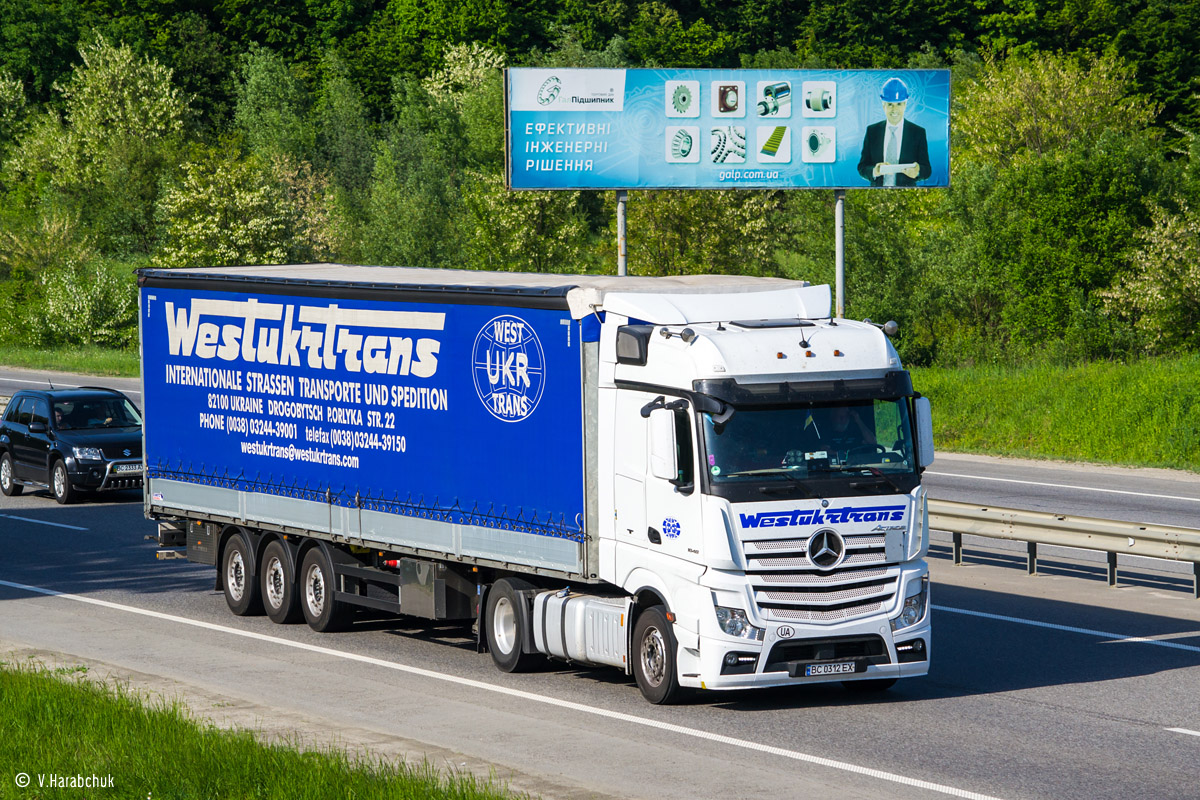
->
[929,500,1200,600]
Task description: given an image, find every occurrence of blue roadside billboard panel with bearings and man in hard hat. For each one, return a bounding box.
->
[505,68,950,190]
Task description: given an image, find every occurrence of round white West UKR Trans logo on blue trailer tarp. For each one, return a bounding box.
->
[472,314,546,422]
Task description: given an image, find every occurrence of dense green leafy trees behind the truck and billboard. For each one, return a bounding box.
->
[0,0,1200,365]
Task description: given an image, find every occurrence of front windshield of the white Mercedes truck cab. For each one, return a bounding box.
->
[703,398,917,500]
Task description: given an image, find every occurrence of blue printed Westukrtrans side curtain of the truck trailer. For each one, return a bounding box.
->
[142,287,583,541]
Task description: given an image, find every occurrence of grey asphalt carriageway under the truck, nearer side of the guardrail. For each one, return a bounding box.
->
[0,493,1200,800]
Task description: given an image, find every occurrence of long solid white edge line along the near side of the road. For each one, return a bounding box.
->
[0,581,997,800]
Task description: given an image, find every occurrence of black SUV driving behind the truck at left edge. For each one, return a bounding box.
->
[0,386,142,503]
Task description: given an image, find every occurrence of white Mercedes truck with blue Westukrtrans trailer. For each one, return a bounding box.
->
[139,264,934,703]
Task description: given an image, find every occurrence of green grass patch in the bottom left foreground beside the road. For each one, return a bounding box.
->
[0,662,517,800]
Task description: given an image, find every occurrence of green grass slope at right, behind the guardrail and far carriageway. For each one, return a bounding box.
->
[912,355,1200,471]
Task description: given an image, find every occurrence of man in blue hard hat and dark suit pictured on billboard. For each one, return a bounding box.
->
[858,78,932,186]
